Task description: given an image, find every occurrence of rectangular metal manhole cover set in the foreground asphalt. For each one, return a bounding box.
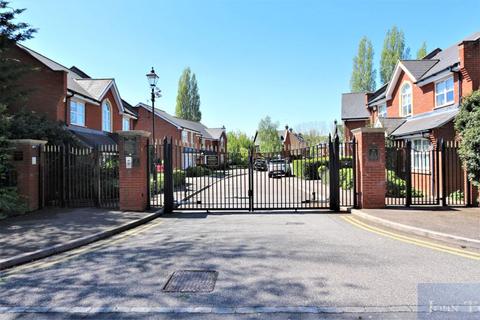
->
[163,270,218,292]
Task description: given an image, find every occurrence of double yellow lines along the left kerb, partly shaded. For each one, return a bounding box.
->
[0,220,162,279]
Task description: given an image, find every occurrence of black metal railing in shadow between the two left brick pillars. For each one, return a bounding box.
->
[40,145,119,208]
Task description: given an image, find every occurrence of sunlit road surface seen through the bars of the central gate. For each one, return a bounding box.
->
[176,169,353,210]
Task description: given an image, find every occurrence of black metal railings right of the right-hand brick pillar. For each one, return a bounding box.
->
[385,140,472,207]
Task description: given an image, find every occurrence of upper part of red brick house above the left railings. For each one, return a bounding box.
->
[8,44,137,145]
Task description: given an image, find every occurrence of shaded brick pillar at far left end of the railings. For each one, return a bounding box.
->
[10,139,47,211]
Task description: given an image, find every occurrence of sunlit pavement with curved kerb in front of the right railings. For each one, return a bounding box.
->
[352,207,480,248]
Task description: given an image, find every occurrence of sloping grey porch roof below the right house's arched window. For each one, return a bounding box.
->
[392,105,458,137]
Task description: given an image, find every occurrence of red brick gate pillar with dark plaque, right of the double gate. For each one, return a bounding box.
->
[352,127,386,209]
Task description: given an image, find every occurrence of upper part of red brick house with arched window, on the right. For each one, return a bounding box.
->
[342,32,480,144]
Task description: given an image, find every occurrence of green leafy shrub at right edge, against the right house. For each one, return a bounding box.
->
[455,90,480,186]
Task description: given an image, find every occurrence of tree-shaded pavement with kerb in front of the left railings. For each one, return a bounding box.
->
[0,208,159,270]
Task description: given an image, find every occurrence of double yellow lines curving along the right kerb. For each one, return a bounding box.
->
[342,217,480,260]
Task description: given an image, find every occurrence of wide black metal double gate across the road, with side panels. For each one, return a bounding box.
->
[147,138,356,211]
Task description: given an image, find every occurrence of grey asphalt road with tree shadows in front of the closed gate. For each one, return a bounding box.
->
[0,213,480,319]
